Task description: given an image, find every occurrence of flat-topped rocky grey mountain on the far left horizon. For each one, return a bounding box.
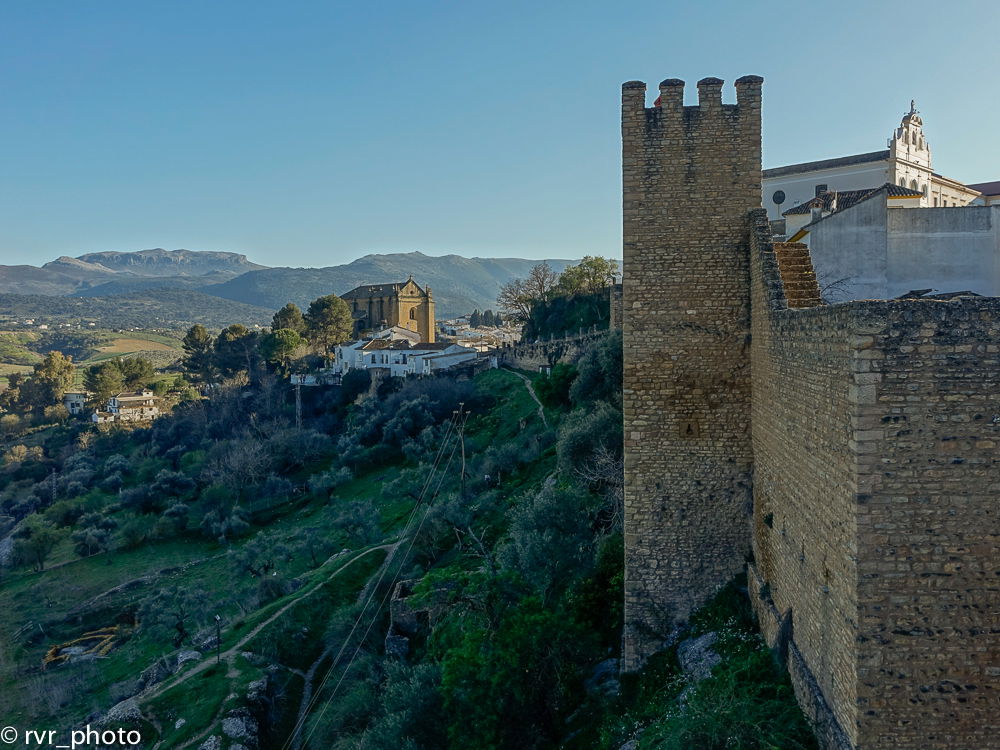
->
[0,248,267,295]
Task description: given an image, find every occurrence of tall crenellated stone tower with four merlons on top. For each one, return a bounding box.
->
[622,76,763,670]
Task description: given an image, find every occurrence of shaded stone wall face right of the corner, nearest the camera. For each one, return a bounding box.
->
[852,296,1000,750]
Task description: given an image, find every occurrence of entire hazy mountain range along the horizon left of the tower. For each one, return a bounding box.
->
[0,248,574,322]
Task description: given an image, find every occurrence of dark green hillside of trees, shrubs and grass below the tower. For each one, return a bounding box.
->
[0,330,811,750]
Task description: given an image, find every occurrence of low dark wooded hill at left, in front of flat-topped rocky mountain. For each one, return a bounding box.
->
[0,289,274,329]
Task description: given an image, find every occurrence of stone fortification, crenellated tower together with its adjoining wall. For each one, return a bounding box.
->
[622,73,1000,750]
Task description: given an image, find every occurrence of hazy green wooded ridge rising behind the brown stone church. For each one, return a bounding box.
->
[201,252,576,318]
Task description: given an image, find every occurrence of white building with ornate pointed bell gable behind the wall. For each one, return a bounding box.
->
[763,102,990,225]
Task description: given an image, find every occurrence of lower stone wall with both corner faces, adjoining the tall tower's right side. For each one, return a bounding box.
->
[750,211,1000,750]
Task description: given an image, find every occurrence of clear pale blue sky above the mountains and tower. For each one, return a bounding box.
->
[0,0,1000,266]
